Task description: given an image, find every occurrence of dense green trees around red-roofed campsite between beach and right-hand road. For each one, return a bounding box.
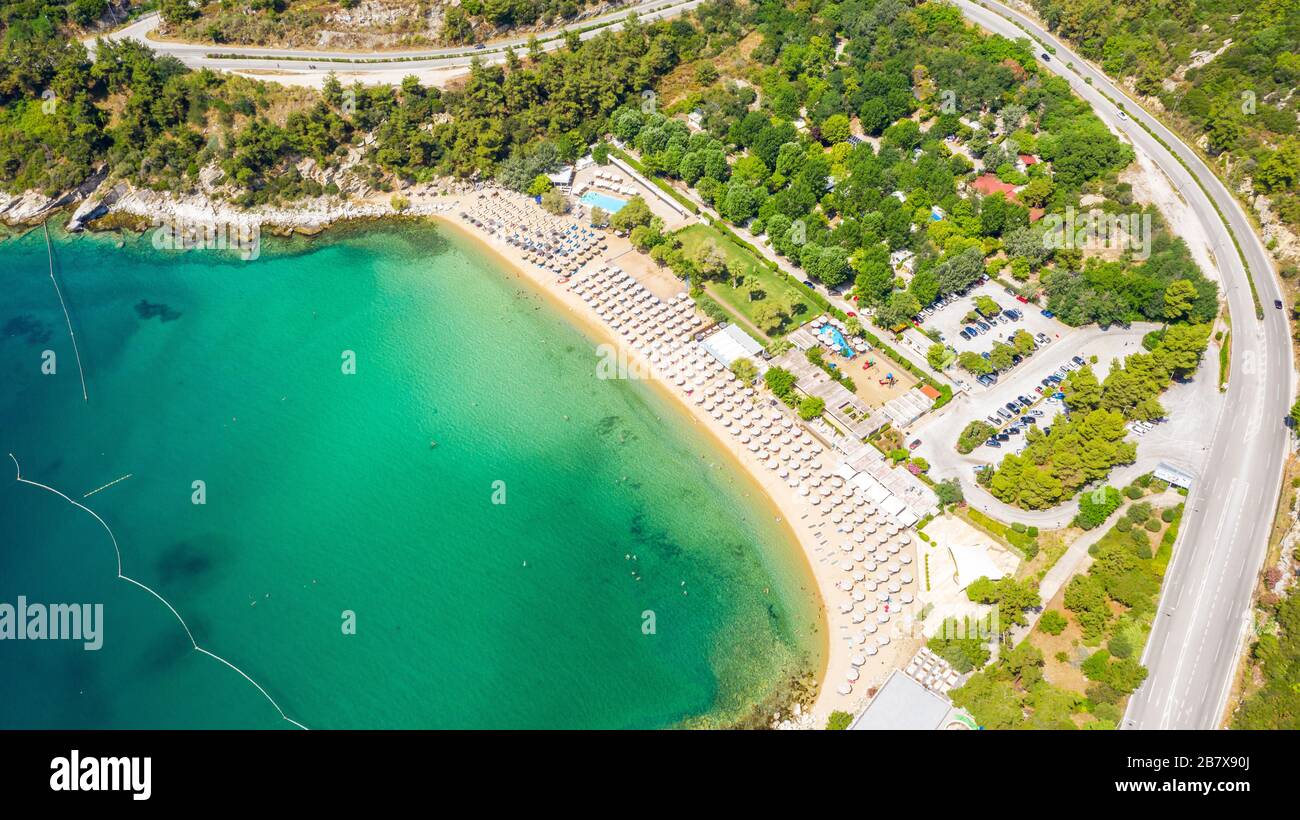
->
[610,0,1170,337]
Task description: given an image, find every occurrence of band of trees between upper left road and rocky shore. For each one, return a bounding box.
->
[0,4,711,204]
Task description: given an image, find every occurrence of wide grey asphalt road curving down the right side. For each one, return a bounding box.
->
[954,0,1295,729]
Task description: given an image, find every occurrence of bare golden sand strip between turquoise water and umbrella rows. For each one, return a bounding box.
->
[436,192,922,729]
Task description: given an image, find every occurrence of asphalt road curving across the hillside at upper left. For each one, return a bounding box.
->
[94,0,703,79]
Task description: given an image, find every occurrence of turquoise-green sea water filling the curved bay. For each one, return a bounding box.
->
[0,224,824,728]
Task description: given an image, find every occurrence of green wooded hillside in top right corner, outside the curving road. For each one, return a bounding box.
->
[1032,0,1300,233]
